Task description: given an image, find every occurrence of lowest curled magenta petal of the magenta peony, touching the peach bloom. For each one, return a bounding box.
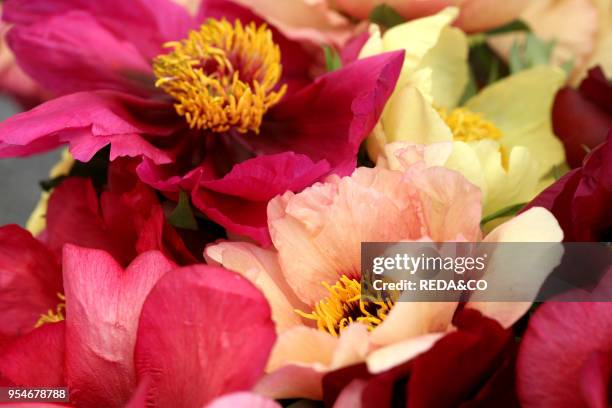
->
[192,152,329,245]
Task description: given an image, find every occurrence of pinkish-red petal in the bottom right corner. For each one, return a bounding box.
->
[517,269,612,408]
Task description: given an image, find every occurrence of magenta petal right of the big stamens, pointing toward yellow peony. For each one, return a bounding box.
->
[245,51,403,175]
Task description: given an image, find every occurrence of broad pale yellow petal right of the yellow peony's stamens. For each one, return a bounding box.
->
[465,66,565,176]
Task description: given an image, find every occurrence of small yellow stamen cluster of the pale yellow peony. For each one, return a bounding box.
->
[438,108,502,142]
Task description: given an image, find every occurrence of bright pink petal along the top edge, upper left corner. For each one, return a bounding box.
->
[3,0,195,59]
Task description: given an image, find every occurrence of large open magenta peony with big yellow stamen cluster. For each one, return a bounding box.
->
[0,0,402,243]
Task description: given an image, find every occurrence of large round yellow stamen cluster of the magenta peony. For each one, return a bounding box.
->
[153,19,287,133]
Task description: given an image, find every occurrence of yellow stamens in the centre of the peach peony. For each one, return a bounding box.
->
[295,275,393,337]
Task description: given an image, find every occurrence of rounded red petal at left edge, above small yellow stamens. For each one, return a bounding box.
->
[0,225,63,340]
